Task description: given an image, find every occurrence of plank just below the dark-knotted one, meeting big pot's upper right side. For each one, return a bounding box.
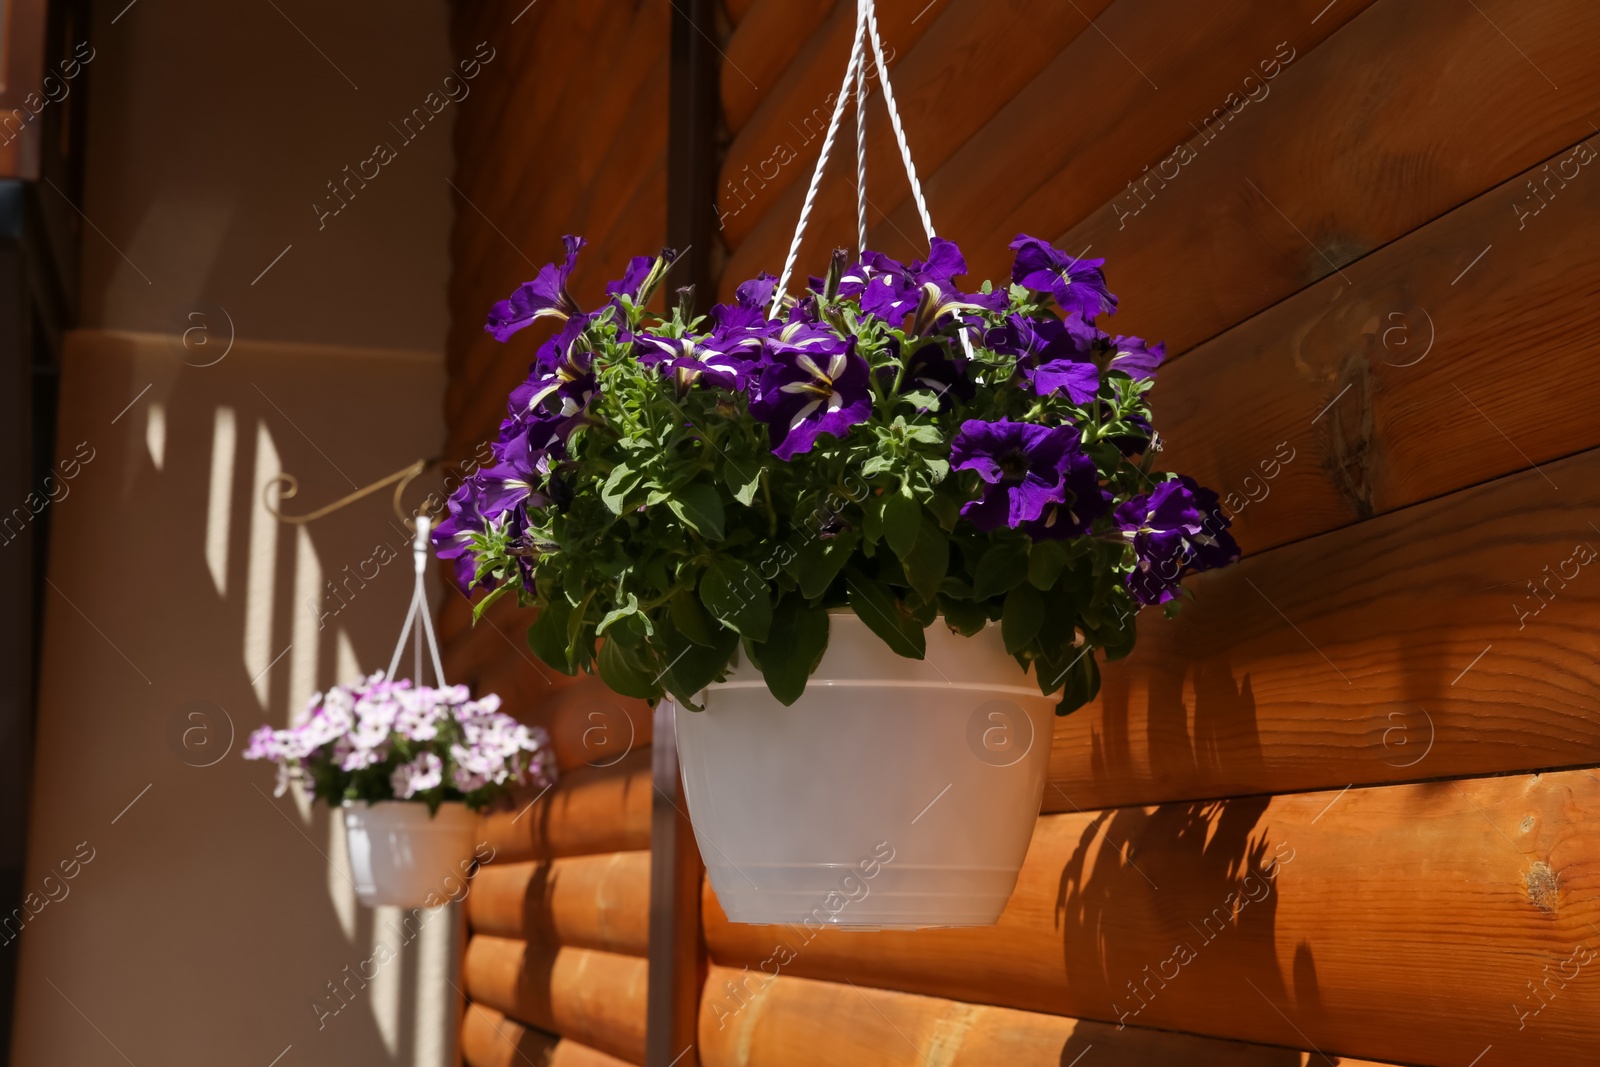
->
[1045,447,1600,809]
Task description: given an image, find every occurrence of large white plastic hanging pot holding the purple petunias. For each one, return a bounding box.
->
[675,613,1056,928]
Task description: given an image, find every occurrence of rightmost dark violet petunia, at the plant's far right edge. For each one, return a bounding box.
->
[1114,475,1238,605]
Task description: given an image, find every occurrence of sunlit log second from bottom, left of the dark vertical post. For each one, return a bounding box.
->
[461,934,645,1064]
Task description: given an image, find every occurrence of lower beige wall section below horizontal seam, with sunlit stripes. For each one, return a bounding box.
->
[5,333,458,1067]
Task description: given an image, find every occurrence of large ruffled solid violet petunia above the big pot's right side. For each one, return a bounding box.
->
[950,419,1104,537]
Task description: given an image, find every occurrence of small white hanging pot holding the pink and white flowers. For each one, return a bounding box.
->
[344,800,477,907]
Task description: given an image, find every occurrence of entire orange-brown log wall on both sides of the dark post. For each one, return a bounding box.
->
[442,0,1600,1067]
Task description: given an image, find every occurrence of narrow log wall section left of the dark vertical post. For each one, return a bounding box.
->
[438,0,672,1067]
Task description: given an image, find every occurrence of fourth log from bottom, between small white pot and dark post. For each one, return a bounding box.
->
[478,745,651,862]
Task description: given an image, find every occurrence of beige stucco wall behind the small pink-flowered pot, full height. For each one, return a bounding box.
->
[12,0,459,1067]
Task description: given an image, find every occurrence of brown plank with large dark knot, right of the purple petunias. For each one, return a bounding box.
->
[1154,136,1600,553]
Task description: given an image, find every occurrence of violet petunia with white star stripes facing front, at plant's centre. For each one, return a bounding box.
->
[750,325,872,459]
